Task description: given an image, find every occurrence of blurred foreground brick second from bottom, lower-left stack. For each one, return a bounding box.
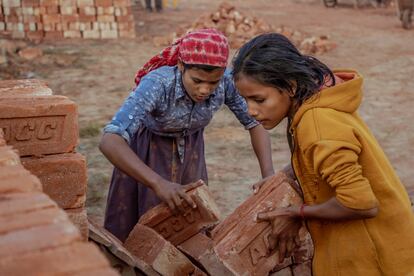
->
[0,220,81,260]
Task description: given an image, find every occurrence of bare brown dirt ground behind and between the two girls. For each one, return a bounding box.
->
[1,0,414,224]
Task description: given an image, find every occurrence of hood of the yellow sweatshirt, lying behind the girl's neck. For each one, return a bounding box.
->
[291,70,363,128]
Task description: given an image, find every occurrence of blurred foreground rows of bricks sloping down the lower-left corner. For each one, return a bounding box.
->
[0,130,118,276]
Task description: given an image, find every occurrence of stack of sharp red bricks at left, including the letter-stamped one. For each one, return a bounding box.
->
[0,77,88,240]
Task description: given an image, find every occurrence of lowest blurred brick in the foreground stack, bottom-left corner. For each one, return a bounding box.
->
[0,242,118,275]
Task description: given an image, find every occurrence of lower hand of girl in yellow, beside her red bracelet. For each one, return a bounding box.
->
[256,207,302,262]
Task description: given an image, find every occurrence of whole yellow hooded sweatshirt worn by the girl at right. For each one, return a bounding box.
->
[290,70,414,276]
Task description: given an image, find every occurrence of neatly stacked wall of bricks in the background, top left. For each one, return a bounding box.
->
[0,0,135,41]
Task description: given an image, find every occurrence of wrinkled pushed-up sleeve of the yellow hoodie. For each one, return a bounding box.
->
[304,140,377,210]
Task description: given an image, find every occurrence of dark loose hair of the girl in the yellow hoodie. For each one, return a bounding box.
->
[233,33,335,105]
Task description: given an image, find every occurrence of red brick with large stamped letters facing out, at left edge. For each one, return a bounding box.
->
[0,96,78,156]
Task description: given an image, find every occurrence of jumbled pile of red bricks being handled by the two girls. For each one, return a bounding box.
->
[124,174,313,276]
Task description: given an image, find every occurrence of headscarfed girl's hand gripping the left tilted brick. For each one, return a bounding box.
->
[154,179,204,214]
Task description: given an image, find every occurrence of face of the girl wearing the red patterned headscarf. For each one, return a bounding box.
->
[178,63,225,102]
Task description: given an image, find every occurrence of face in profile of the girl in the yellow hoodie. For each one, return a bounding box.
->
[236,73,293,129]
